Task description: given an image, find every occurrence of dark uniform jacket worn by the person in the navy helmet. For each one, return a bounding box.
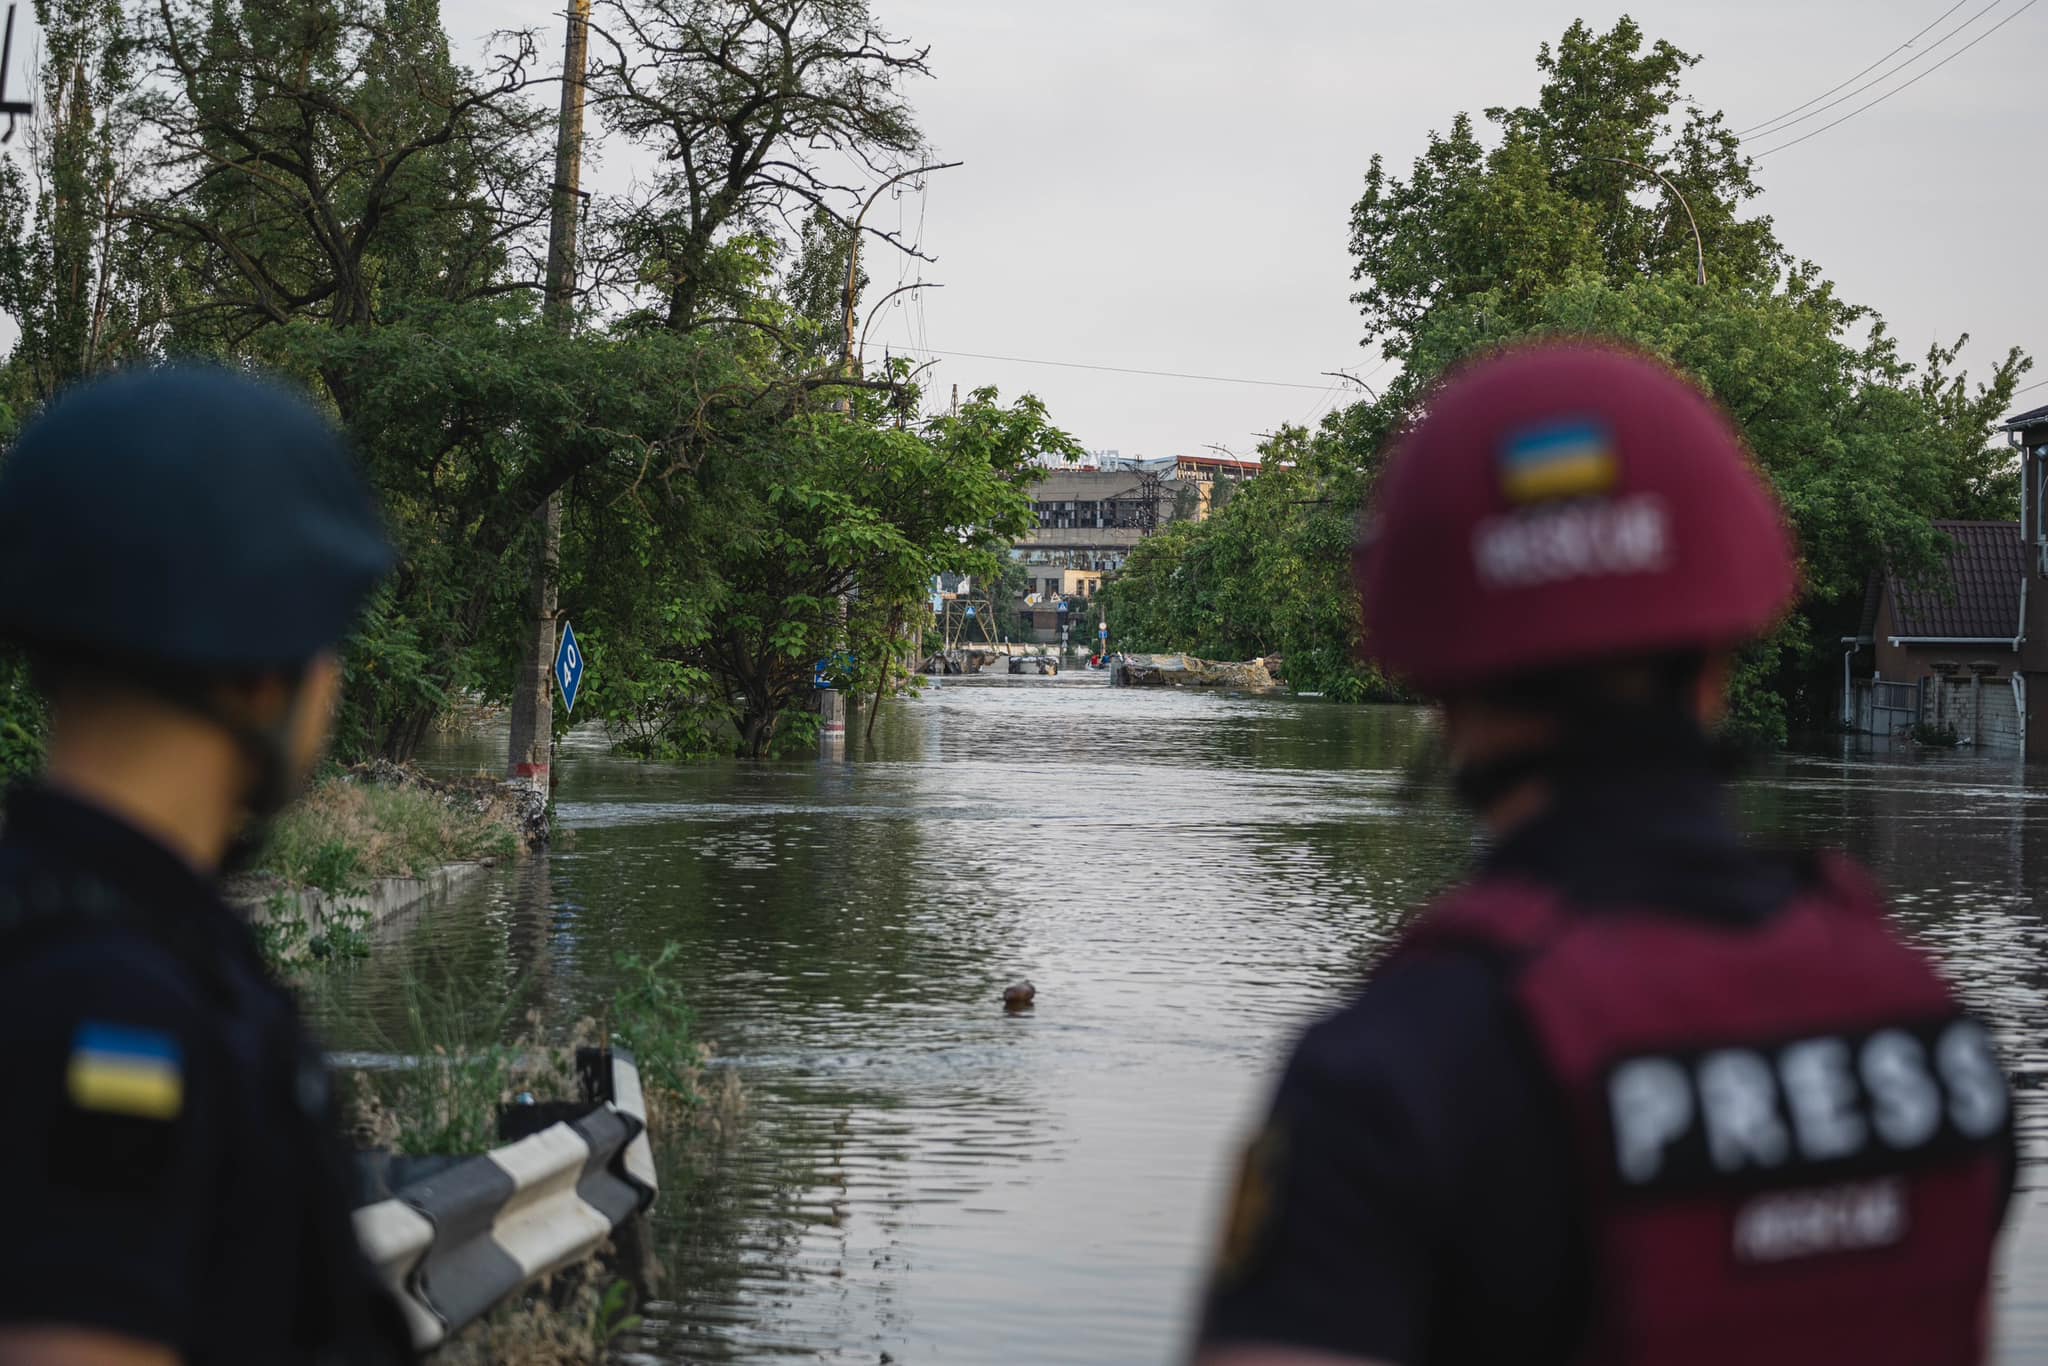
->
[0,786,410,1366]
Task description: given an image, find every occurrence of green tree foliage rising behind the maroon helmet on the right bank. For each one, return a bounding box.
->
[1112,18,2028,739]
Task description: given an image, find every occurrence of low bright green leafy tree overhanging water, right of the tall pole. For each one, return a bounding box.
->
[581,389,1079,756]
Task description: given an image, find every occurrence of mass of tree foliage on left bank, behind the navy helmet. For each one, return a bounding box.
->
[0,0,1073,764]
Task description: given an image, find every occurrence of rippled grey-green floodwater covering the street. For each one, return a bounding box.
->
[313,674,2048,1366]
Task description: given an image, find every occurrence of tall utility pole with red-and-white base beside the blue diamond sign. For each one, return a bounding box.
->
[506,0,590,793]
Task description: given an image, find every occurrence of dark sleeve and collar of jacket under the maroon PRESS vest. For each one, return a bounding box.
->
[1202,774,2009,1366]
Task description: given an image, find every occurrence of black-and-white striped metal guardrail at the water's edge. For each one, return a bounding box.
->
[356,1049,655,1350]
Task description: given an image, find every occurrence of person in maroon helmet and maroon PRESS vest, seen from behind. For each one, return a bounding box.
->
[1196,342,2013,1366]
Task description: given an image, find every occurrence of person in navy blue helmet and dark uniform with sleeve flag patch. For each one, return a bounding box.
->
[0,367,412,1366]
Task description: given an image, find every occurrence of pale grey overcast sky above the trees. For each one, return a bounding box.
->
[23,0,2048,455]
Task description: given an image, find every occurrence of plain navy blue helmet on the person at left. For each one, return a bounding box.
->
[0,365,393,674]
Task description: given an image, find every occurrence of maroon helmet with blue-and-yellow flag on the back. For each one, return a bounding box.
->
[1356,342,1796,692]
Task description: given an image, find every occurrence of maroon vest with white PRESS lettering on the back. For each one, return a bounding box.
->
[1397,858,2011,1366]
